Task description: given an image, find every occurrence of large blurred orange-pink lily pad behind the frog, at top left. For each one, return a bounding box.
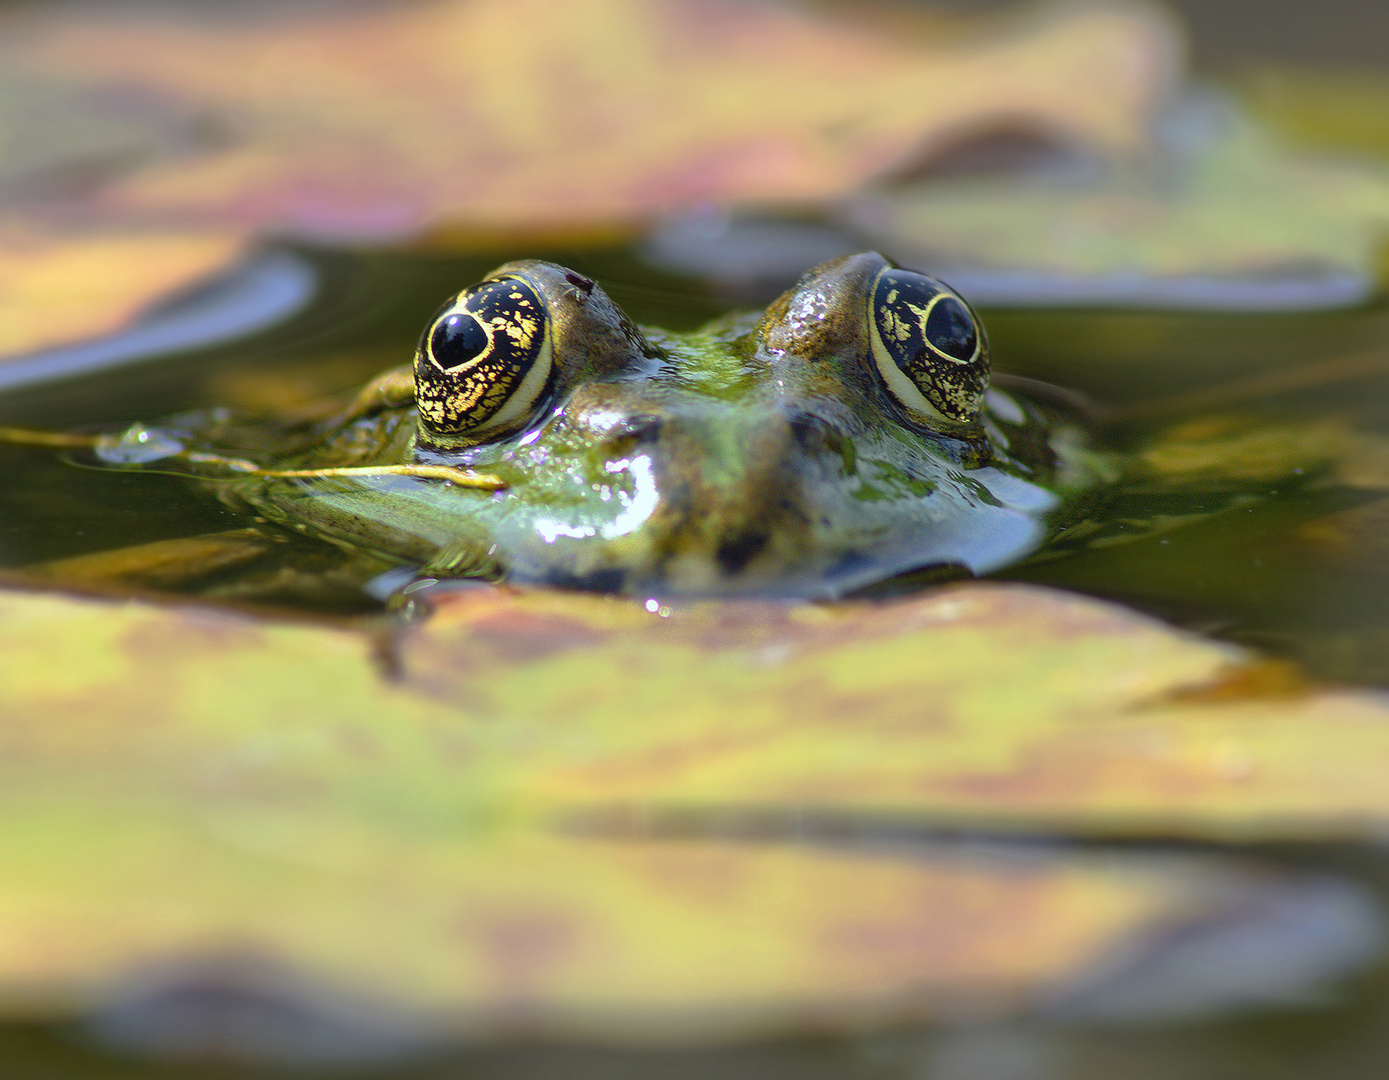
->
[0,0,1175,354]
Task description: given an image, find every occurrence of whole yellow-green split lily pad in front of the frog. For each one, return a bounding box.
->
[0,587,1389,1049]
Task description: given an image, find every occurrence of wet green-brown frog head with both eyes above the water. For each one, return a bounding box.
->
[92,253,1093,596]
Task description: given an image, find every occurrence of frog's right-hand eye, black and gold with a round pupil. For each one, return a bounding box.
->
[868,267,989,423]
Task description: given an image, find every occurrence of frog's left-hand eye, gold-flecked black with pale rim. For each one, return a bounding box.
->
[415,278,553,437]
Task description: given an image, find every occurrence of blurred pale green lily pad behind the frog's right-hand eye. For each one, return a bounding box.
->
[851,97,1389,310]
